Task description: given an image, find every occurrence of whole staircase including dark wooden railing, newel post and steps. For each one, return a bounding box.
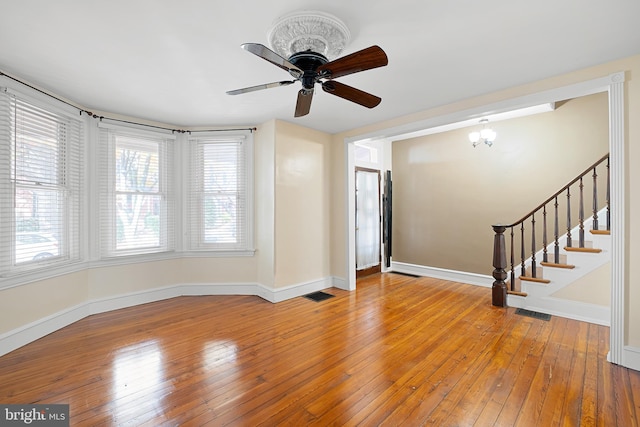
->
[492,154,611,325]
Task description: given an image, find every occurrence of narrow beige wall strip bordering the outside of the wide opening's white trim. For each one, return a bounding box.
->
[331,55,640,347]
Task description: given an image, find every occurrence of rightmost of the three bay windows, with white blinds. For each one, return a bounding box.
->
[187,135,252,251]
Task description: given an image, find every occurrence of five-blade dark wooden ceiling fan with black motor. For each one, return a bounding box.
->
[227,43,388,117]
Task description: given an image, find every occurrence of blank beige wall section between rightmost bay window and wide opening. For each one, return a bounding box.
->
[275,121,331,287]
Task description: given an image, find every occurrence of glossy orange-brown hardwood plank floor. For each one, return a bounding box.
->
[0,274,640,427]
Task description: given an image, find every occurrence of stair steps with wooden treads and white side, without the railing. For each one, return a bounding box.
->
[507,211,611,325]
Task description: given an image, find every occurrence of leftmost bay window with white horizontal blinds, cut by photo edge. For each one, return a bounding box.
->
[0,90,84,277]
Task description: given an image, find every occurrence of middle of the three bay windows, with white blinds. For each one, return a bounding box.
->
[99,125,175,257]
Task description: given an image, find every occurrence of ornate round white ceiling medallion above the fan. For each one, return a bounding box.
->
[267,10,351,61]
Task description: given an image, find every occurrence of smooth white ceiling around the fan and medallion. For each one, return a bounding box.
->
[0,0,640,133]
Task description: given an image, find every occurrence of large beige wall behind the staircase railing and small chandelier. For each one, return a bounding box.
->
[392,93,609,275]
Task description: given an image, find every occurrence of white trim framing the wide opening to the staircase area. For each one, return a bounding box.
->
[343,72,628,369]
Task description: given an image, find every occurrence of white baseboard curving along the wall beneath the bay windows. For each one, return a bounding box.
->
[0,277,344,356]
